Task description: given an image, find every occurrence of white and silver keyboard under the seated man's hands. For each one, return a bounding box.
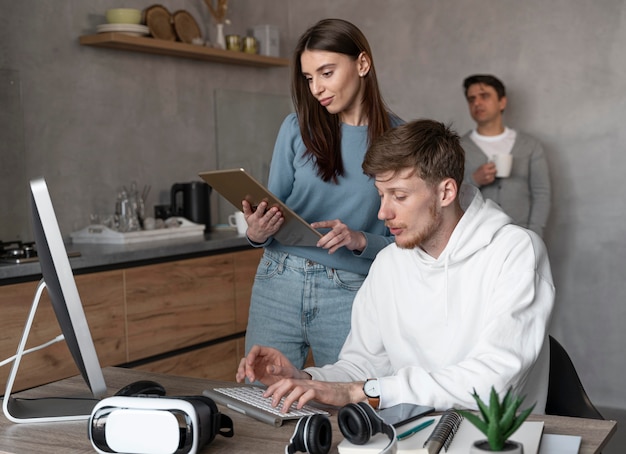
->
[202,386,329,427]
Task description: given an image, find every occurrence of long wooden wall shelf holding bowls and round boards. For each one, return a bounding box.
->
[79,32,289,67]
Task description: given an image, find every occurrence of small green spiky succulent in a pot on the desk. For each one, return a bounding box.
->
[458,386,535,454]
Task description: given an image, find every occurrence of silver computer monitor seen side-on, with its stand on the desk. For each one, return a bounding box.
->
[2,179,107,423]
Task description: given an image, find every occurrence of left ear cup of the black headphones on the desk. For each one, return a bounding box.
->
[285,415,333,454]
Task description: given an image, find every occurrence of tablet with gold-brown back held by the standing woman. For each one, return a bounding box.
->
[199,169,322,246]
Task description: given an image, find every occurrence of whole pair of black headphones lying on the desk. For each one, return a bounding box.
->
[285,402,398,454]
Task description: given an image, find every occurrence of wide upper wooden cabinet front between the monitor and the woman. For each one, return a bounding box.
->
[125,254,235,361]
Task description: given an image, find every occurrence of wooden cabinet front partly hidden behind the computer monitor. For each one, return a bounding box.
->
[0,271,126,394]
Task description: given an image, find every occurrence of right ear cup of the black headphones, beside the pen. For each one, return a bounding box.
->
[337,402,397,454]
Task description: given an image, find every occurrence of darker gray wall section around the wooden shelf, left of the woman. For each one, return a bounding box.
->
[0,0,289,239]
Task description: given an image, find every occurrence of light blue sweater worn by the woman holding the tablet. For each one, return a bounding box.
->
[263,113,402,274]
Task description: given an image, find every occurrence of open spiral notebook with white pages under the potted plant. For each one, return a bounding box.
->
[337,415,543,454]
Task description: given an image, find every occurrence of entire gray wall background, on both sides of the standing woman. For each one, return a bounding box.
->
[0,0,626,407]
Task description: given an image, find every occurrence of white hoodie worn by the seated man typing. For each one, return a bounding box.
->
[306,185,554,413]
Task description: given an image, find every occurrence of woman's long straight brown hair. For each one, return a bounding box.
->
[291,19,390,183]
